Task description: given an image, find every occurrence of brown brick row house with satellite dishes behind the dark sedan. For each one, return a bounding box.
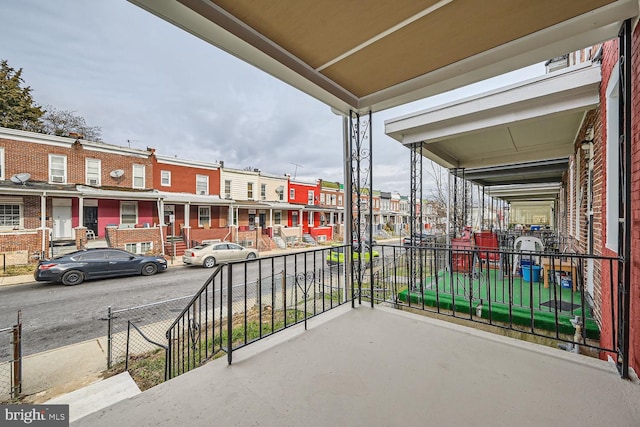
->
[0,128,161,261]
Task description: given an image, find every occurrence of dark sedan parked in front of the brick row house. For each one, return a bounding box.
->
[33,248,167,286]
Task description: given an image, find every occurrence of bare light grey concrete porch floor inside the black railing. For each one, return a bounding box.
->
[72,306,640,427]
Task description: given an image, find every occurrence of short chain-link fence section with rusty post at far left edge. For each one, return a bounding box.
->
[0,311,22,402]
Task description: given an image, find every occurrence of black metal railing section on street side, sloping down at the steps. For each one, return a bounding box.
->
[166,245,356,378]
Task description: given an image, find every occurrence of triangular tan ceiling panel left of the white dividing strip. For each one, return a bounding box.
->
[213,0,438,68]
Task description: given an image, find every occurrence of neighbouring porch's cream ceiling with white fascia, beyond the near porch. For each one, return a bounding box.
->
[385,62,601,171]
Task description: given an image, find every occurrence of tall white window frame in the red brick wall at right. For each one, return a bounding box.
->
[605,63,620,253]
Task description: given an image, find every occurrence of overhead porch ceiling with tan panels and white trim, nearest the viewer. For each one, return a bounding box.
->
[129,0,638,113]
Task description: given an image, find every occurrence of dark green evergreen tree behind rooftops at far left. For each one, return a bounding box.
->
[0,59,44,132]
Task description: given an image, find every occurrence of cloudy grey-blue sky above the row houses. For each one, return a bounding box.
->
[0,0,543,194]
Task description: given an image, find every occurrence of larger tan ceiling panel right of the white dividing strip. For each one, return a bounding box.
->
[323,0,611,96]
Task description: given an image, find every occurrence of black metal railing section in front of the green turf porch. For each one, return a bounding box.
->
[371,245,618,354]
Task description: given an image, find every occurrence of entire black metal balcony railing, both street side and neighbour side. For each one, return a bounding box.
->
[166,245,618,378]
